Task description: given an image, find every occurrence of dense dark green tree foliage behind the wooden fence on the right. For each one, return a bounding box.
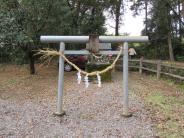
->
[131,0,184,59]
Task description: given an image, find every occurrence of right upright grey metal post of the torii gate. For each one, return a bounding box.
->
[123,42,130,117]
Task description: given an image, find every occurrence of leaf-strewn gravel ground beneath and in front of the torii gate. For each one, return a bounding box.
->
[0,66,154,138]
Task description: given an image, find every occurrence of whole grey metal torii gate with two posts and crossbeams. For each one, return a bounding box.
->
[40,36,148,116]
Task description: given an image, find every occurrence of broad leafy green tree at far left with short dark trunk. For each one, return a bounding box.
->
[0,0,70,74]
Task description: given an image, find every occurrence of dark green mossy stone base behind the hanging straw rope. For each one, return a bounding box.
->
[86,63,112,82]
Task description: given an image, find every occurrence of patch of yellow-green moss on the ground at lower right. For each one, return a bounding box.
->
[146,92,183,138]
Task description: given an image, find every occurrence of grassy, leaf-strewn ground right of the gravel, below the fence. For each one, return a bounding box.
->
[131,75,184,138]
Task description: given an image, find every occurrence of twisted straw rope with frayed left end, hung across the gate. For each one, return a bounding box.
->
[35,46,123,76]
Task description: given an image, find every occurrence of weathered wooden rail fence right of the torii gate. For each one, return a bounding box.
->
[116,58,184,81]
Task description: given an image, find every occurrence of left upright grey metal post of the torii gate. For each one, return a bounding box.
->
[55,42,65,116]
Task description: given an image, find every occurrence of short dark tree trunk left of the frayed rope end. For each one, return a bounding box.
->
[28,50,35,75]
